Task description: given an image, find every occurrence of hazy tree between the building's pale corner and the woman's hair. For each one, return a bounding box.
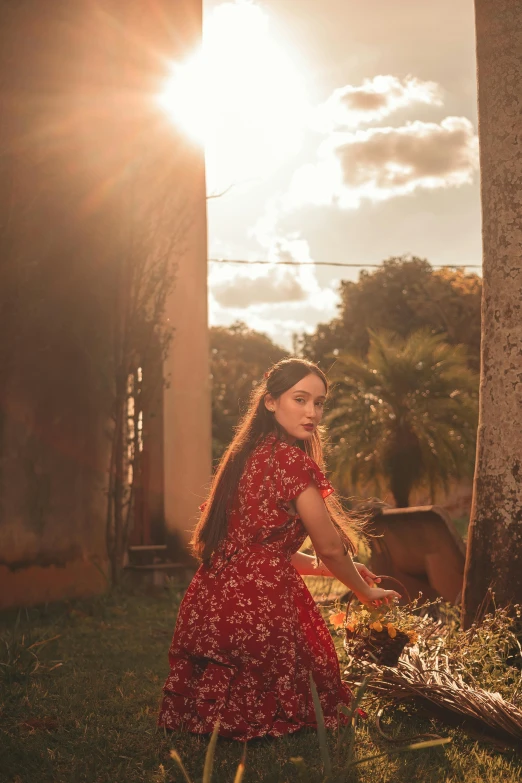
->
[210,321,288,459]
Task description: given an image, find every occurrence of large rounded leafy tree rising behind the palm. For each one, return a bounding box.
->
[300,256,481,371]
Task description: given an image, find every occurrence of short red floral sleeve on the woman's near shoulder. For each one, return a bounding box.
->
[275,447,335,502]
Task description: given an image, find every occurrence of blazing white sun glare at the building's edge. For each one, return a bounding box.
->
[158,0,309,187]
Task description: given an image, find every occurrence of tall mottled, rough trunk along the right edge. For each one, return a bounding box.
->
[463,0,522,626]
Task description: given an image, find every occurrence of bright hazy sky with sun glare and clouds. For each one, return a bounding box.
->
[159,0,481,347]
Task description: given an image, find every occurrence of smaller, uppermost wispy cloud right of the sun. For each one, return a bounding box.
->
[312,75,442,133]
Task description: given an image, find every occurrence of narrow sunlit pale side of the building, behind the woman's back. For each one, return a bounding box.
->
[164,0,212,547]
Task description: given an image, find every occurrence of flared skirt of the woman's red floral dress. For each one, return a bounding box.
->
[155,564,351,741]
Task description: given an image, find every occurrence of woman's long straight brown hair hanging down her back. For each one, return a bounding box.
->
[191,359,355,563]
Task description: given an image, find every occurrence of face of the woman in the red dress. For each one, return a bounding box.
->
[265,373,326,443]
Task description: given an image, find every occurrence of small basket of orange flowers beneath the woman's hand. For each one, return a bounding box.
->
[329,577,421,667]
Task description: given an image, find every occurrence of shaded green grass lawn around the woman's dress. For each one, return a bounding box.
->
[0,587,522,783]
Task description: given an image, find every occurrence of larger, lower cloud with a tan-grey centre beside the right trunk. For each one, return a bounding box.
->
[284,117,478,209]
